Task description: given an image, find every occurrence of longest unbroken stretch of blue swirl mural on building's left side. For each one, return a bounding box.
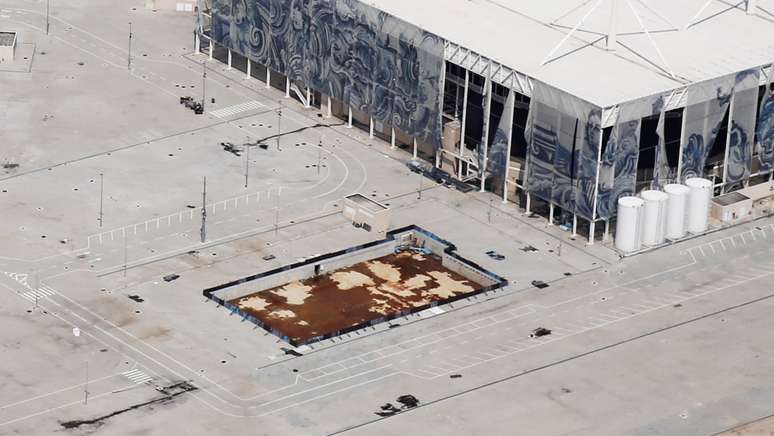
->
[212,0,444,147]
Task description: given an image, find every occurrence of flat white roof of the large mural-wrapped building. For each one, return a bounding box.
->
[369,0,774,107]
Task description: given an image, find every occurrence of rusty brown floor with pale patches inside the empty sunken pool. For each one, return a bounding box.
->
[229,252,482,342]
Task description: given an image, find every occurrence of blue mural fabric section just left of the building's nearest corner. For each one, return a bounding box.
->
[525,82,602,220]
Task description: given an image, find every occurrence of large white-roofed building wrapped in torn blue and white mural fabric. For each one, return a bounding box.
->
[197,0,774,241]
